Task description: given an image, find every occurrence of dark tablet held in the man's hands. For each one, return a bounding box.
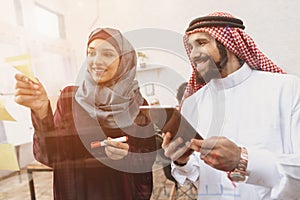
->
[140,106,203,157]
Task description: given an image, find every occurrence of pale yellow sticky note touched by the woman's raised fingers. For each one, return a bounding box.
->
[5,54,38,83]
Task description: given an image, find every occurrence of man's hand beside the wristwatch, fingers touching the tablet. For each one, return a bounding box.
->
[190,136,241,171]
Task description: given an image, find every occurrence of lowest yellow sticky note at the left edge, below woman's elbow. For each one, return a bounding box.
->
[0,144,20,171]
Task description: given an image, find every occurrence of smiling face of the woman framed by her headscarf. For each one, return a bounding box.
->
[87,39,120,84]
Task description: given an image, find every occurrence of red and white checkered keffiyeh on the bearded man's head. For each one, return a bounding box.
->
[183,12,285,100]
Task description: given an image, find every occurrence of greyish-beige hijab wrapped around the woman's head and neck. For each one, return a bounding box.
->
[75,28,144,128]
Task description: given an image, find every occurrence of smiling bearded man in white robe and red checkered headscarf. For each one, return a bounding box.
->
[162,12,300,200]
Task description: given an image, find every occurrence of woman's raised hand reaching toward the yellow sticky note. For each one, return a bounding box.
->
[15,74,49,119]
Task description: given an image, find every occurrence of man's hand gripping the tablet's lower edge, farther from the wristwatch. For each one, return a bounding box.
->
[161,132,192,164]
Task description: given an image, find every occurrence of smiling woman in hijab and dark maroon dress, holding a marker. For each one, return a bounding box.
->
[15,28,156,200]
